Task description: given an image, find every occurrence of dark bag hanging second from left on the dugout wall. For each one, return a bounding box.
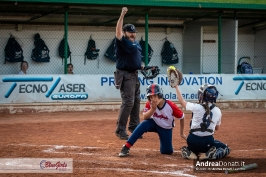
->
[31,33,50,62]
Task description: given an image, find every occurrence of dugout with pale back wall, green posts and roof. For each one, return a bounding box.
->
[0,0,266,74]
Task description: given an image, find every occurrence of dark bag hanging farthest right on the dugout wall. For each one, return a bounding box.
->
[161,39,178,65]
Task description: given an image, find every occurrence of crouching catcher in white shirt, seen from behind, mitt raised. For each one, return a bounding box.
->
[167,66,230,160]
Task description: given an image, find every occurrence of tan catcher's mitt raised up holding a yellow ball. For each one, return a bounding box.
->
[167,66,183,88]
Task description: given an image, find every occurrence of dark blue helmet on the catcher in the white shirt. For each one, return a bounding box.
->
[198,84,219,103]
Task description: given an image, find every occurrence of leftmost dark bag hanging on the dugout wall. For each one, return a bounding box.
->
[5,35,24,63]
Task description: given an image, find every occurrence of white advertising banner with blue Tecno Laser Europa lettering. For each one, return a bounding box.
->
[0,74,266,103]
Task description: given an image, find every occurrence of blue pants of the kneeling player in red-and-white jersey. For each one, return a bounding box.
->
[127,119,173,154]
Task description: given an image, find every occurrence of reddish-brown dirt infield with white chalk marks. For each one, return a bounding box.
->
[0,109,266,177]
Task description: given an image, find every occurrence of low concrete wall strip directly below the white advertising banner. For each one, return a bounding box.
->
[0,100,266,114]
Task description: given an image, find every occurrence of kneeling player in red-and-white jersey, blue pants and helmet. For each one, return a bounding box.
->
[119,84,186,157]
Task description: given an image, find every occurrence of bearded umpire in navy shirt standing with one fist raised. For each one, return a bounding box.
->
[115,7,142,140]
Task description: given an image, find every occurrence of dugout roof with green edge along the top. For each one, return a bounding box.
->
[0,0,266,30]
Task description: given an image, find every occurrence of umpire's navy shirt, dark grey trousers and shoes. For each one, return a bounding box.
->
[115,36,142,139]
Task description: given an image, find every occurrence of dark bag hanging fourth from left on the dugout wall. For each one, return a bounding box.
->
[84,37,100,67]
